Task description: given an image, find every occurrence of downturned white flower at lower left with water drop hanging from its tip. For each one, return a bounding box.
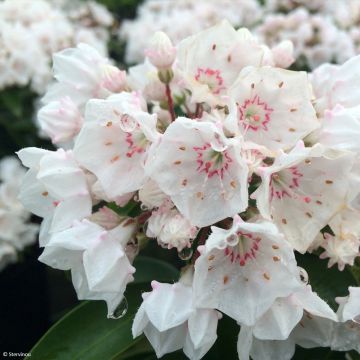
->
[39,220,135,316]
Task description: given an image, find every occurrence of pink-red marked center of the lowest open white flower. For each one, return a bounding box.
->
[225,231,261,266]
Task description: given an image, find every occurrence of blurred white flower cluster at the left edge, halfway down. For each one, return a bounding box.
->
[0,157,38,270]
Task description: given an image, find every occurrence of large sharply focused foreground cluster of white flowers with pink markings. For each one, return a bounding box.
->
[18,21,360,360]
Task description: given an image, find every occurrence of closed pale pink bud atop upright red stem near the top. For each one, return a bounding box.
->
[145,31,176,69]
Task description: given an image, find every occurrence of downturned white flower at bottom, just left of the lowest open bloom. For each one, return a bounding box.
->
[132,281,220,360]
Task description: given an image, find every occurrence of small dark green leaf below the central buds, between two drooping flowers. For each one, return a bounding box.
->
[134,256,179,283]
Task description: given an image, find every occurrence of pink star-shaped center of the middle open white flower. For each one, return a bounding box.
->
[193,143,232,179]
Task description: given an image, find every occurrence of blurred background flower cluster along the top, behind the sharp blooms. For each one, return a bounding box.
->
[120,0,360,69]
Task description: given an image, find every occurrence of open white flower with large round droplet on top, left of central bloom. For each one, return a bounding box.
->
[74,92,158,199]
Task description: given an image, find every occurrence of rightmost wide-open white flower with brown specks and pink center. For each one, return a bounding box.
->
[254,142,354,252]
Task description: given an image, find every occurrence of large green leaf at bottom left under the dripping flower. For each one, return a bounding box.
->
[31,285,142,360]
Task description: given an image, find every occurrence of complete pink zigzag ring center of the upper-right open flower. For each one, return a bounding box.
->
[238,95,274,131]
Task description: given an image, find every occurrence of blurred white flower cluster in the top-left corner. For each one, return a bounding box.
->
[0,0,113,94]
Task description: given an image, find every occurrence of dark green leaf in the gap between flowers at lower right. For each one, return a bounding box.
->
[297,254,356,310]
